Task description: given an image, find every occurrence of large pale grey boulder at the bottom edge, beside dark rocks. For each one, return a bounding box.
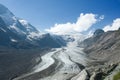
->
[71,69,89,80]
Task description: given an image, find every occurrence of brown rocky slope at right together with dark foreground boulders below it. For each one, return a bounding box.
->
[79,29,120,80]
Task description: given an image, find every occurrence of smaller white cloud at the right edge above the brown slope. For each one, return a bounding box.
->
[103,18,120,32]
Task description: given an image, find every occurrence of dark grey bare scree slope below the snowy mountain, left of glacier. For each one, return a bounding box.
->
[0,47,49,80]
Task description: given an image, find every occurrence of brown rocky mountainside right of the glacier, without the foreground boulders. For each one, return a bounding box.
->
[80,30,120,63]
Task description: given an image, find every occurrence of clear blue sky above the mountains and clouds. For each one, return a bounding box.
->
[0,0,120,33]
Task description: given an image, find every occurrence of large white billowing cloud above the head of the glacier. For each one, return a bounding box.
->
[45,13,104,34]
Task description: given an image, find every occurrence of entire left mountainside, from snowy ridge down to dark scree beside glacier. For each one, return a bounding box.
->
[0,4,66,80]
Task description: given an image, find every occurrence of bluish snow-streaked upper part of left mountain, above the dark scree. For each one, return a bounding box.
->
[0,4,65,48]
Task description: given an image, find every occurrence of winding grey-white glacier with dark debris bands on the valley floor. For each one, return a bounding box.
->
[14,42,92,80]
